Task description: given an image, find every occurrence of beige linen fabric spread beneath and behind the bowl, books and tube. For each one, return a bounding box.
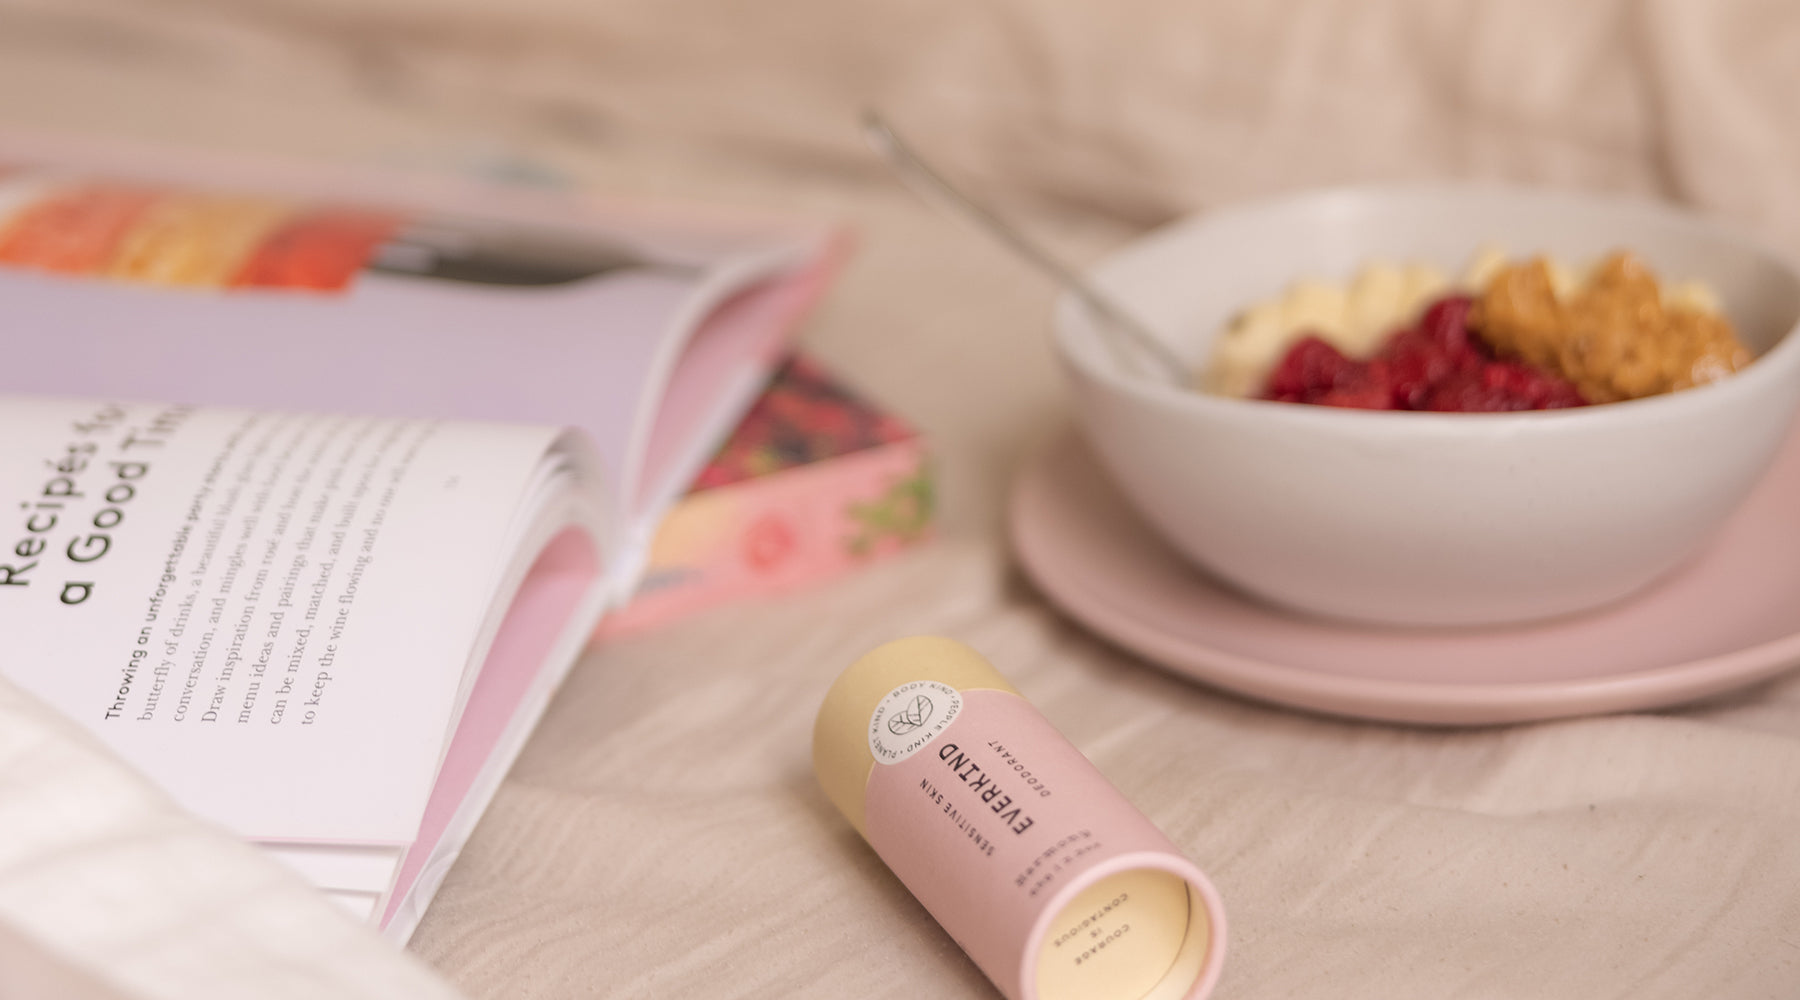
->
[0,0,1800,1000]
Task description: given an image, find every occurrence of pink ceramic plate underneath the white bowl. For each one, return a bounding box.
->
[1012,432,1800,725]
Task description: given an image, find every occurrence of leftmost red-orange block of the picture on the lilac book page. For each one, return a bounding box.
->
[0,185,158,273]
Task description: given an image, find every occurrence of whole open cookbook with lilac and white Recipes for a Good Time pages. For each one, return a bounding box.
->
[0,140,841,941]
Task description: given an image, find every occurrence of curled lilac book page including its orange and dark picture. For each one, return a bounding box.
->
[0,162,823,575]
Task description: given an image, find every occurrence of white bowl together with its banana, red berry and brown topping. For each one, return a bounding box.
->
[1055,187,1800,626]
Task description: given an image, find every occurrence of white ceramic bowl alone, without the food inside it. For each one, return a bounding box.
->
[1055,185,1800,626]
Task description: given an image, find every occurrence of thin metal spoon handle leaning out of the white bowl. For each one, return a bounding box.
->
[862,112,1190,385]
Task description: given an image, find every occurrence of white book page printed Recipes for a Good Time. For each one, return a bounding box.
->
[0,397,601,844]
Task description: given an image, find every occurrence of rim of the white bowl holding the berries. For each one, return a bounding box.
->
[1051,182,1800,435]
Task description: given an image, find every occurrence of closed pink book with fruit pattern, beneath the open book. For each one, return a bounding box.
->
[598,356,932,637]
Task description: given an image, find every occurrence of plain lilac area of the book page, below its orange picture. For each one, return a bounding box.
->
[0,268,698,517]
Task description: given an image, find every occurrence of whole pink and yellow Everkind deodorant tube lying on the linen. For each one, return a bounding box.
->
[812,637,1226,1000]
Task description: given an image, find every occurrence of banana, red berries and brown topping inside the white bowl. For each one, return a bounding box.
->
[1199,250,1751,412]
